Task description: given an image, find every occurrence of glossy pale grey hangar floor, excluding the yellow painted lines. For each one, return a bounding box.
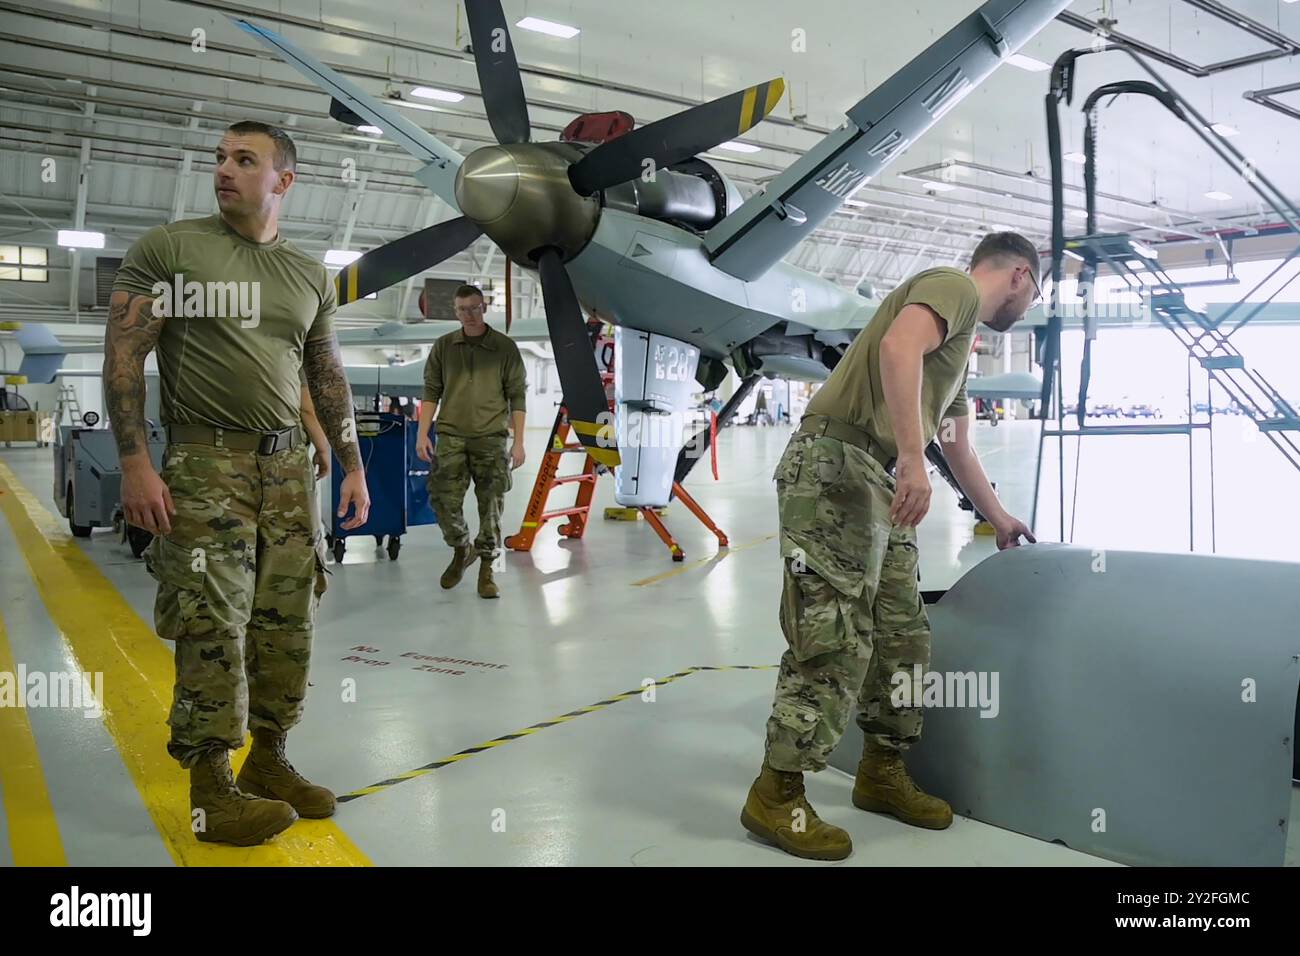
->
[0,419,1300,865]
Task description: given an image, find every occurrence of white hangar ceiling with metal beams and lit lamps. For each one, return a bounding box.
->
[0,0,1300,335]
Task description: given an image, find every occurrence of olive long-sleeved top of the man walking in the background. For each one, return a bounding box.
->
[424,325,528,438]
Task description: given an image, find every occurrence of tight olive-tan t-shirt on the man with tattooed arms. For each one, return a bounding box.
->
[113,215,335,432]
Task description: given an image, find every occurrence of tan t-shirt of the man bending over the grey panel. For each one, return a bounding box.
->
[807,267,979,455]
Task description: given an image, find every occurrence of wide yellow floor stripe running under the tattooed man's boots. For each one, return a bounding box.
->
[0,462,372,866]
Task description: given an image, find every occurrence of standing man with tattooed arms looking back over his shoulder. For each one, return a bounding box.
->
[104,122,369,845]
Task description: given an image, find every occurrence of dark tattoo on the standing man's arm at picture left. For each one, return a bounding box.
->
[104,291,164,458]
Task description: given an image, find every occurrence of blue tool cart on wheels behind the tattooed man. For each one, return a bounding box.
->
[326,412,438,562]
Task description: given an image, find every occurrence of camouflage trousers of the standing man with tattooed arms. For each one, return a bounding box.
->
[146,444,326,769]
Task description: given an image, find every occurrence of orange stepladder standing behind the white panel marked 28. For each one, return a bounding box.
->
[506,382,728,561]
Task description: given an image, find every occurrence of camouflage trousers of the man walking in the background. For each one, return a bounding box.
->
[429,434,511,559]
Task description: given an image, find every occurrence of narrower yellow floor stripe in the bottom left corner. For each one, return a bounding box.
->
[0,606,68,866]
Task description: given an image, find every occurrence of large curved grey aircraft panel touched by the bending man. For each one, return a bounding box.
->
[831,545,1300,866]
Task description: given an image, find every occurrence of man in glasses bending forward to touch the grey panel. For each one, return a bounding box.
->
[741,233,1039,860]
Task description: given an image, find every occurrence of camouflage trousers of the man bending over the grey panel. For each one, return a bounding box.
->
[767,432,930,771]
